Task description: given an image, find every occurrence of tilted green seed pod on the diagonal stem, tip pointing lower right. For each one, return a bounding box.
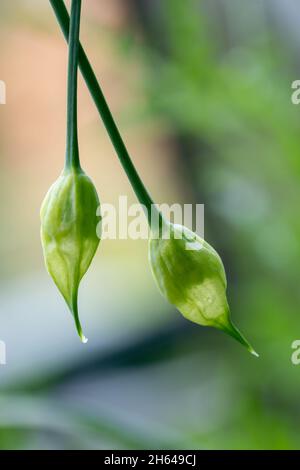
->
[149,221,257,355]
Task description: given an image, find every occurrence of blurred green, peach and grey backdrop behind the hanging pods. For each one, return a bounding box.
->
[0,0,300,449]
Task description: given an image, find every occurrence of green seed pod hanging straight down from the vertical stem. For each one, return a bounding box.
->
[41,168,100,342]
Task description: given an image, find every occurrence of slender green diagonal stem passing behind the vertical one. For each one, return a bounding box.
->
[49,0,161,223]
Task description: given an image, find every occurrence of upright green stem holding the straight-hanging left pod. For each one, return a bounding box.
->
[65,0,81,169]
